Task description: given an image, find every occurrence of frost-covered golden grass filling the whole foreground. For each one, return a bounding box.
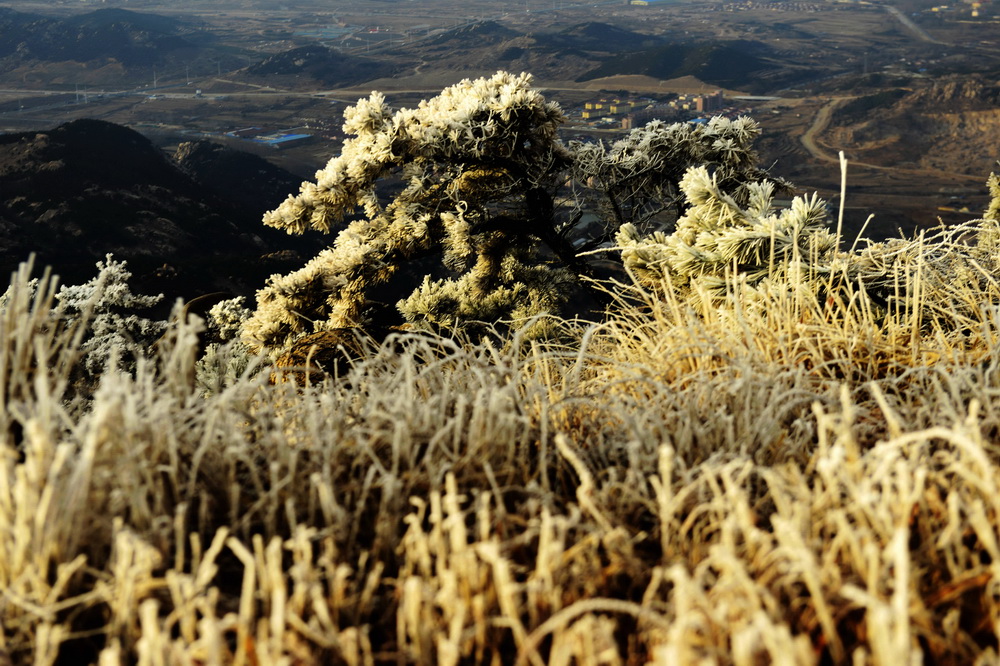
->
[0,226,1000,666]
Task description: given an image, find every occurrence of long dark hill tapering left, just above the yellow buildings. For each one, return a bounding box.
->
[577,42,775,89]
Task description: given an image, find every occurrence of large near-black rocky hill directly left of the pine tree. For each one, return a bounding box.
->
[0,120,329,299]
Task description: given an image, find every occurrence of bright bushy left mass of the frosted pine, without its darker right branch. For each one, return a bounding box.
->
[244,73,572,350]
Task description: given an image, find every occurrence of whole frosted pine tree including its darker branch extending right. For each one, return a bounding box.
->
[243,72,780,354]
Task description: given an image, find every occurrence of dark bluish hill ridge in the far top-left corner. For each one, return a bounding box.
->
[0,8,197,69]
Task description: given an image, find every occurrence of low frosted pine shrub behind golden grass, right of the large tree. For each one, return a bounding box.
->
[616,162,1000,336]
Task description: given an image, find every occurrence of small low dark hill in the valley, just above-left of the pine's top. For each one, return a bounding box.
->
[243,44,395,87]
